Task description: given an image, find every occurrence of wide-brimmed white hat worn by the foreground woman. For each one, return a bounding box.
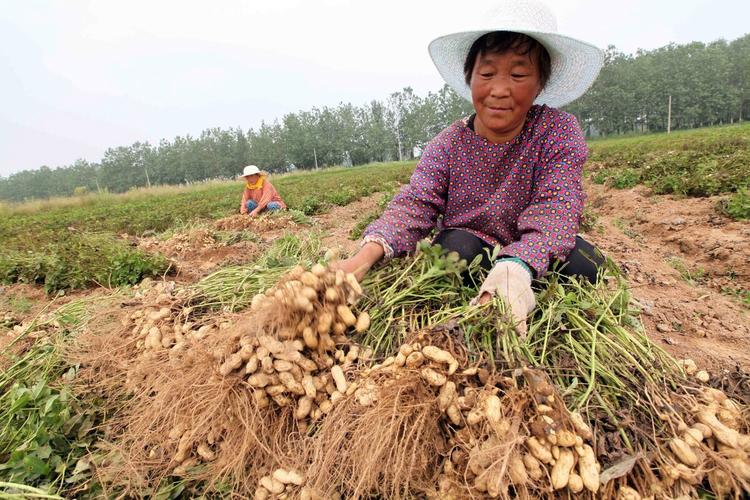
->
[429,0,604,107]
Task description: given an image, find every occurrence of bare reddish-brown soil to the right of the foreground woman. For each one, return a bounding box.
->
[587,184,750,369]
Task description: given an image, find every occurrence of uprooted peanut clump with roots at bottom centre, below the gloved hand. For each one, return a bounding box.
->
[298,335,599,498]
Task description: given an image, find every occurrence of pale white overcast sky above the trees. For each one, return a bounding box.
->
[0,0,750,176]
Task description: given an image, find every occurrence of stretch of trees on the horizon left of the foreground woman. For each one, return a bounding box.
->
[0,85,471,201]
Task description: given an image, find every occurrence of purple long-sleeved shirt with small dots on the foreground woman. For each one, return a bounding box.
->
[365,105,588,277]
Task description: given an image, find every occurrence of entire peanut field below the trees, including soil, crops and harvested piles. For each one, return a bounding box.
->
[0,125,750,498]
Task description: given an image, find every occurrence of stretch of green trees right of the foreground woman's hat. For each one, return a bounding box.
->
[566,34,750,135]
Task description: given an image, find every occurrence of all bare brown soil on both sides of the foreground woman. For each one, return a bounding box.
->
[0,178,750,368]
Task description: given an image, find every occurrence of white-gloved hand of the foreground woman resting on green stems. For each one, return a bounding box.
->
[471,261,536,337]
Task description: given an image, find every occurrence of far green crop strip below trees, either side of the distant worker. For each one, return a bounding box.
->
[0,162,414,250]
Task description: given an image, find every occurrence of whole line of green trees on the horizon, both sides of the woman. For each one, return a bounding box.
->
[0,35,750,201]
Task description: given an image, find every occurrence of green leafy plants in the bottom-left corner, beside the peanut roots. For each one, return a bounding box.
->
[0,296,108,498]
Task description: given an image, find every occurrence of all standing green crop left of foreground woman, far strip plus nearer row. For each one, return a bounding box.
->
[0,162,414,292]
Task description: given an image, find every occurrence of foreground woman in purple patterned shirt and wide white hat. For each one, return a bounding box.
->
[338,0,603,334]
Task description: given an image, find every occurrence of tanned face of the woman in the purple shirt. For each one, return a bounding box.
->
[470,51,542,143]
